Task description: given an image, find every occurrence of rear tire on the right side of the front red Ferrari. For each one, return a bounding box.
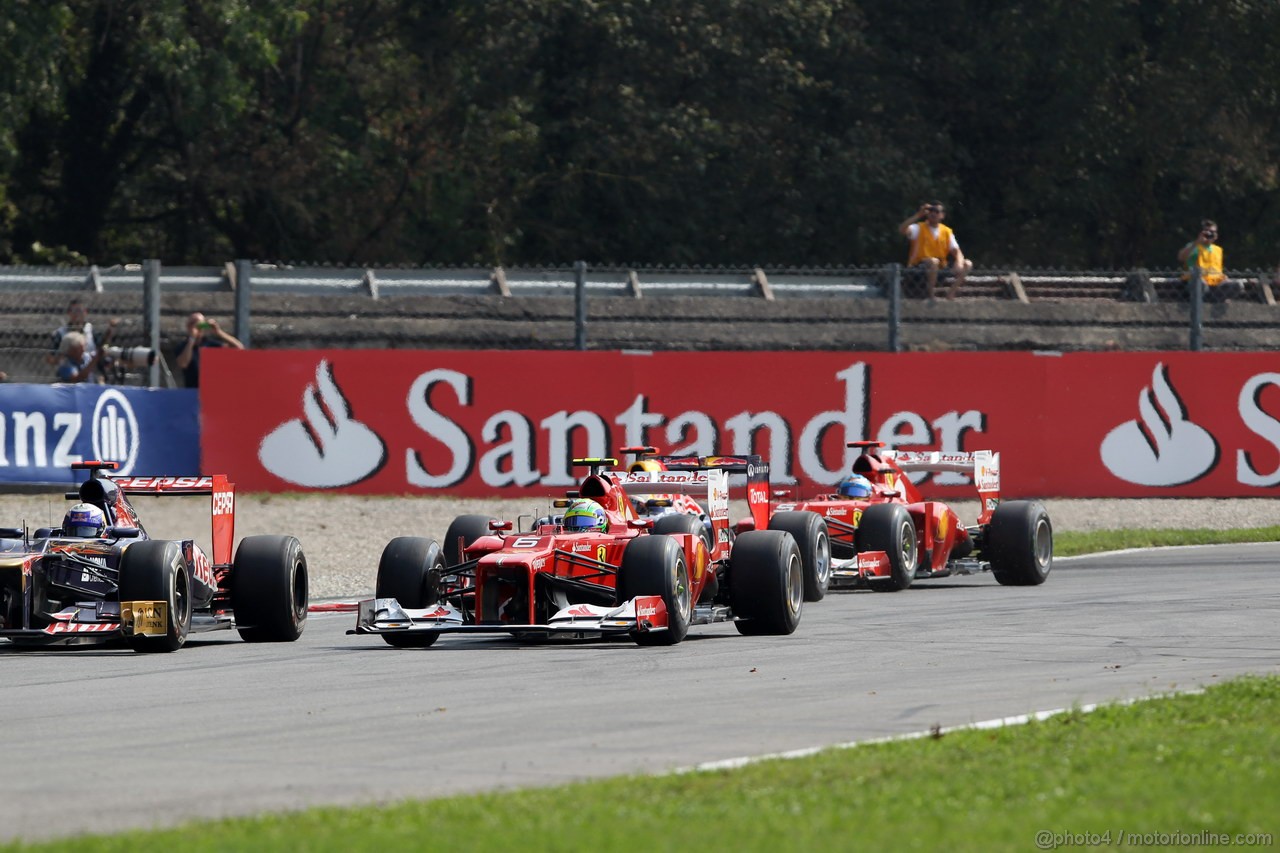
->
[730,530,804,637]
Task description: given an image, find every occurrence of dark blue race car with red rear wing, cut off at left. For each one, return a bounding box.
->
[0,462,307,652]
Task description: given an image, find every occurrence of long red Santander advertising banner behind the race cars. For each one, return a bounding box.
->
[200,350,1280,497]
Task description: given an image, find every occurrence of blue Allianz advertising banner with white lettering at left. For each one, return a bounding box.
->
[0,384,200,484]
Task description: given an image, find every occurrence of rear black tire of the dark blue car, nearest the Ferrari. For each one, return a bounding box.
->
[232,535,310,643]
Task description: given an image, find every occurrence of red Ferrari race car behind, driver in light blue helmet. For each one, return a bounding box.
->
[769,442,1053,592]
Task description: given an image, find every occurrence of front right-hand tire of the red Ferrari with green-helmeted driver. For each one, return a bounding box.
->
[617,532,696,646]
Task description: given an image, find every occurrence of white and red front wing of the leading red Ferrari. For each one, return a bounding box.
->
[347,596,667,635]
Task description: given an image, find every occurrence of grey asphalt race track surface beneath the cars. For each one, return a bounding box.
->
[0,543,1280,840]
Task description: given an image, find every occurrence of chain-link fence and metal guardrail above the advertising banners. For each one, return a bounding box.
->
[0,260,1280,386]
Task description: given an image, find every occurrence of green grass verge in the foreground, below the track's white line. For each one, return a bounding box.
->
[10,678,1280,853]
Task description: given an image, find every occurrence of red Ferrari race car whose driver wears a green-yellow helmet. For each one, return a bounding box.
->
[348,457,819,647]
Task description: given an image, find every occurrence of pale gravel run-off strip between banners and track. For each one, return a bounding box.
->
[0,492,1280,601]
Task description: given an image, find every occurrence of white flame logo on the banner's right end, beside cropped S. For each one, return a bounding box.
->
[1101,364,1219,485]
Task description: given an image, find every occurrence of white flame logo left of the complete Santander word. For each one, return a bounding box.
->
[257,361,387,488]
